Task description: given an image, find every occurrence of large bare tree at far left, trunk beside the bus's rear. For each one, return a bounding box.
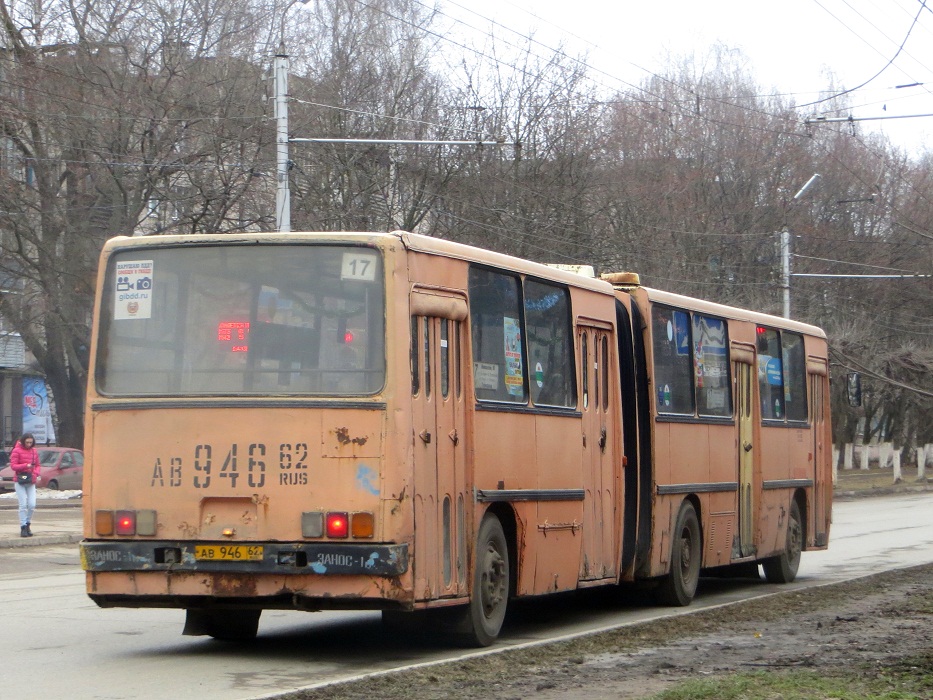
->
[0,0,282,445]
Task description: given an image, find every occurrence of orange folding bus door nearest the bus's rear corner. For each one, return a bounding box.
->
[411,316,467,600]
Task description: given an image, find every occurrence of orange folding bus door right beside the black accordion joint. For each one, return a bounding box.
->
[577,324,616,580]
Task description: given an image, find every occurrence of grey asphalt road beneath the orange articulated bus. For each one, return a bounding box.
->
[0,494,933,700]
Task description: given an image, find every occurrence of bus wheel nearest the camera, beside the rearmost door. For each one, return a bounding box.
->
[455,515,510,647]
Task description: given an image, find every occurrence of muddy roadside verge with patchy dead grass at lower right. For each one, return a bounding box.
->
[288,474,933,700]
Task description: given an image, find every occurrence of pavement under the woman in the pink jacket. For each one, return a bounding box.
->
[0,497,84,548]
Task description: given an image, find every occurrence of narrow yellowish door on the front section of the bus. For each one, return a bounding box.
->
[732,356,757,559]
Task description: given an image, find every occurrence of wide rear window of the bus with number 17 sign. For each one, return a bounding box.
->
[96,244,385,396]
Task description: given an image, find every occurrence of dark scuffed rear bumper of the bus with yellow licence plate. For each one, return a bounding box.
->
[80,540,408,576]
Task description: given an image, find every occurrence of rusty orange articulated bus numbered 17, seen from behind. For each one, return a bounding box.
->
[81,232,831,645]
